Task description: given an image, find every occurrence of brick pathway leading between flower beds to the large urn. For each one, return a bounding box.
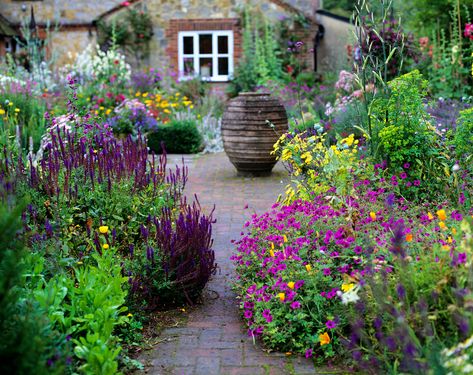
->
[142,153,320,375]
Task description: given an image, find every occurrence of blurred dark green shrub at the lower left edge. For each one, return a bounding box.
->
[0,204,66,374]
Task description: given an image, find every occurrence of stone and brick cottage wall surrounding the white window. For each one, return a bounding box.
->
[1,0,319,76]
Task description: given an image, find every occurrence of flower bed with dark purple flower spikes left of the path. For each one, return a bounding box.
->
[0,79,215,374]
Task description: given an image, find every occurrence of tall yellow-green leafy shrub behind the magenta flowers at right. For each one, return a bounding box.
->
[370,70,452,199]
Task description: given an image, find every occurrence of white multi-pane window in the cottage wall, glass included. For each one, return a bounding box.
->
[178,31,233,82]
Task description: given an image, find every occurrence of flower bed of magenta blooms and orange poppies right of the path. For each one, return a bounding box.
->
[233,172,473,371]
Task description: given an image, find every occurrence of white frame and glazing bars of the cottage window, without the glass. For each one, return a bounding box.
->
[178,30,233,82]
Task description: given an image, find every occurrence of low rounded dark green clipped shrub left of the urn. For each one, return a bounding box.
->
[148,120,202,154]
